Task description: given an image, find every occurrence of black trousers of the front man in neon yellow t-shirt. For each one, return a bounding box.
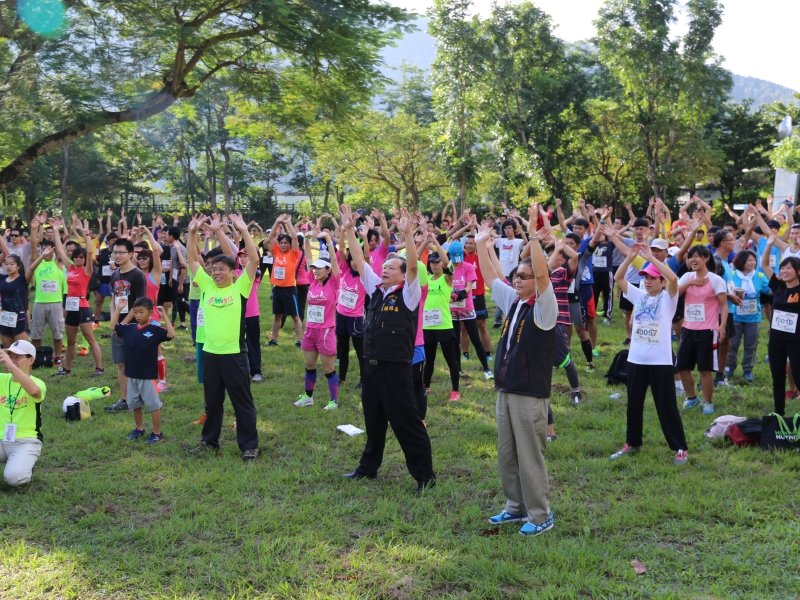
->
[201,352,258,452]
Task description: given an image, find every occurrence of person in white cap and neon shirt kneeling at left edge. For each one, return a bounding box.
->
[0,340,47,487]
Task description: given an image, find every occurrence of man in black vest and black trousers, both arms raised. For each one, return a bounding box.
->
[342,205,436,493]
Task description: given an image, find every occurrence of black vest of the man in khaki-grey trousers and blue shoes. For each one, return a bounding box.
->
[494,300,556,398]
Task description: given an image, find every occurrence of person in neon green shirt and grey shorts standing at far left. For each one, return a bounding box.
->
[25,240,64,366]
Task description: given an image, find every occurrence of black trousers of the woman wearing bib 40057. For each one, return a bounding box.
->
[626,362,688,452]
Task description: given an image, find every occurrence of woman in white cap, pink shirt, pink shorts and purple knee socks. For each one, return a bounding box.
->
[294,229,339,410]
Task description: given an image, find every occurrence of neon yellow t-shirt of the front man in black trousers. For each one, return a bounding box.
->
[194,269,253,354]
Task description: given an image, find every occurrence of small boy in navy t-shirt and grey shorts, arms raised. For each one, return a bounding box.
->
[111,298,175,444]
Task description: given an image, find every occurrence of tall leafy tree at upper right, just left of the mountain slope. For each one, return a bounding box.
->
[595,0,732,197]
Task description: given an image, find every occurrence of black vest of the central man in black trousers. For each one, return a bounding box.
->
[364,285,419,364]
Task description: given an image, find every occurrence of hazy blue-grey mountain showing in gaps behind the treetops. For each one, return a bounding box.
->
[382,18,800,108]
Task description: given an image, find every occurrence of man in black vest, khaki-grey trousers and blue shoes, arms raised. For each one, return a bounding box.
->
[475,203,558,535]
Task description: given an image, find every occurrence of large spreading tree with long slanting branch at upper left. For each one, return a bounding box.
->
[0,0,408,191]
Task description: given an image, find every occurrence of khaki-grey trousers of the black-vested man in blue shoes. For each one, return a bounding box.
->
[496,392,550,525]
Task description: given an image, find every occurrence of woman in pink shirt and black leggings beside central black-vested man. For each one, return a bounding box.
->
[336,243,367,389]
